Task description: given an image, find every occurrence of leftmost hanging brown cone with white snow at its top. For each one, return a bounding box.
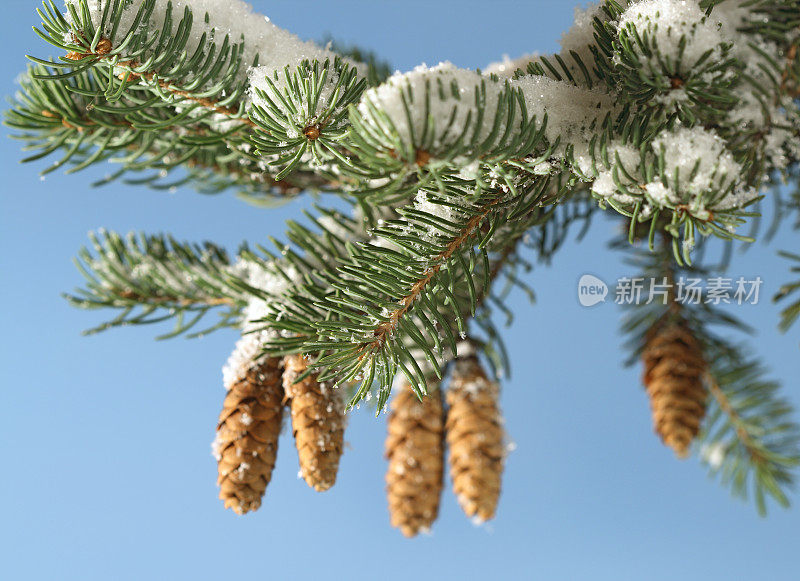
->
[212,336,283,514]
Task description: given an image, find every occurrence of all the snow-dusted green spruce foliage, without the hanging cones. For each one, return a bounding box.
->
[6,0,800,511]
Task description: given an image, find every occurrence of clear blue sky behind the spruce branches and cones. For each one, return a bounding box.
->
[0,0,800,581]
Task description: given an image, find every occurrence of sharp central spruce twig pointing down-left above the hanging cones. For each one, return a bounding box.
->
[255,176,564,408]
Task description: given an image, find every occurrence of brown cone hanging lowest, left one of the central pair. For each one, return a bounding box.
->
[386,384,444,537]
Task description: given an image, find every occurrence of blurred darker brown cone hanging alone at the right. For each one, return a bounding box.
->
[642,321,708,458]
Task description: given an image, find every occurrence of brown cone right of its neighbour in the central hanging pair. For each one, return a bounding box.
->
[446,356,505,522]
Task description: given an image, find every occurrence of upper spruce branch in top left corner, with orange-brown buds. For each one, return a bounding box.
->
[31,0,251,124]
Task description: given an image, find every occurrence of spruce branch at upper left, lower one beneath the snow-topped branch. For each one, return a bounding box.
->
[6,65,310,197]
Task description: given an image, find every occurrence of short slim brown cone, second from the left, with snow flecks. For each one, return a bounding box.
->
[283,355,344,492]
